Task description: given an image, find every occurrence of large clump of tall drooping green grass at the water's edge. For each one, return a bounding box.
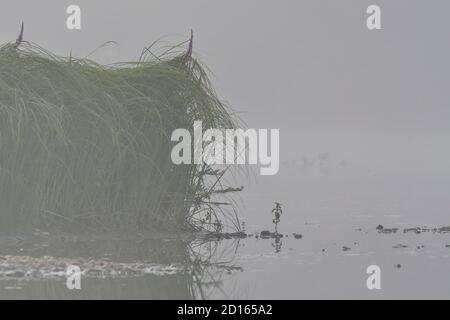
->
[0,37,241,232]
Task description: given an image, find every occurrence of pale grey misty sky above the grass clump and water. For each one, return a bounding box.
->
[0,0,450,133]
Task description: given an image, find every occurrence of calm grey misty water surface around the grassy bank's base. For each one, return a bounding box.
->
[0,134,450,299]
